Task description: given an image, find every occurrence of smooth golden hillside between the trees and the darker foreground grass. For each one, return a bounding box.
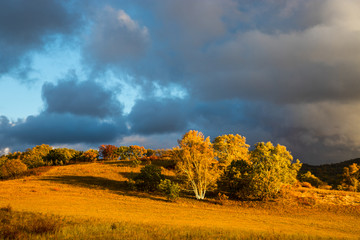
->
[0,163,360,239]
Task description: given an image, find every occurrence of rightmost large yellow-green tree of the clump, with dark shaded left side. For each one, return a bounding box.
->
[218,142,301,199]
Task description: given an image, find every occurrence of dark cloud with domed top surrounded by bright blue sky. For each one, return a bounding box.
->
[42,76,122,118]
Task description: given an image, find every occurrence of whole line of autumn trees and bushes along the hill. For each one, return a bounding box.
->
[0,130,360,199]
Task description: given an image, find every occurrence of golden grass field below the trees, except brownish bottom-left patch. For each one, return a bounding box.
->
[0,162,360,239]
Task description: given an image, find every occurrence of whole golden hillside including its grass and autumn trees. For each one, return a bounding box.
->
[0,131,360,239]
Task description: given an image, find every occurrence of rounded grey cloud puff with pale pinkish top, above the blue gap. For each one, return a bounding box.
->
[84,6,150,65]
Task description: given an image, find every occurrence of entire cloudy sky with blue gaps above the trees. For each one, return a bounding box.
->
[0,0,360,164]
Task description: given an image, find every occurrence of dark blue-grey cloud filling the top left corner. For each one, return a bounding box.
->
[0,0,80,73]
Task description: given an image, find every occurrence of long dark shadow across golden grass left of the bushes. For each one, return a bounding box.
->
[41,176,167,202]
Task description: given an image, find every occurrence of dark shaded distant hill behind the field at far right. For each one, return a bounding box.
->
[299,158,360,188]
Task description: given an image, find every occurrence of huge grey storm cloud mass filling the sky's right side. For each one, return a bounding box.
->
[112,0,360,163]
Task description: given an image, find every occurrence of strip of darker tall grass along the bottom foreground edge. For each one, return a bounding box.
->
[0,207,335,240]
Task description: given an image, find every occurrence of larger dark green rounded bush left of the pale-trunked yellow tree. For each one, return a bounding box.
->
[134,165,164,192]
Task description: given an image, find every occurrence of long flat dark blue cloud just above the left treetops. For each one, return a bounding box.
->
[0,113,126,147]
